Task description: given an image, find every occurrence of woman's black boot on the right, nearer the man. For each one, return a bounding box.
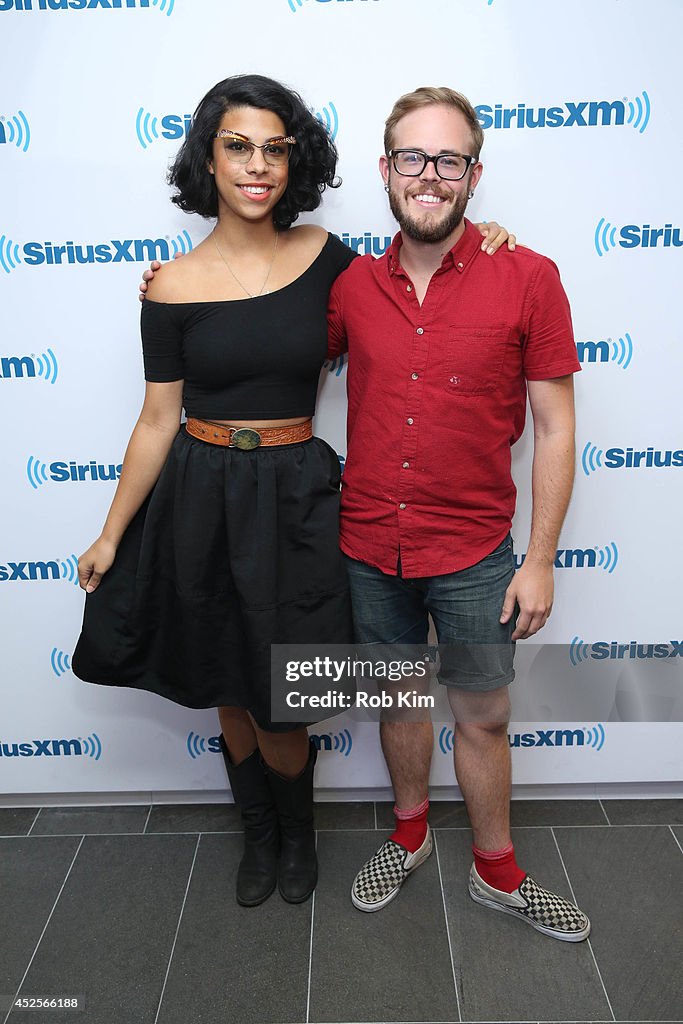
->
[265,743,317,903]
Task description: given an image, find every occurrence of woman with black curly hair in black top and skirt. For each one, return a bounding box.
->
[73,75,511,906]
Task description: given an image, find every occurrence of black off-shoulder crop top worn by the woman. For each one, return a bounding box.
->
[141,234,356,420]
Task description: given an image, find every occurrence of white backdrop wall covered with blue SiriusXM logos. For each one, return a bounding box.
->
[0,0,683,795]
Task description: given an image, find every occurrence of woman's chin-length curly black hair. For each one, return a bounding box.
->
[168,75,341,230]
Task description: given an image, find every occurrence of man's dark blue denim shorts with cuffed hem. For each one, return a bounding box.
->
[344,535,518,692]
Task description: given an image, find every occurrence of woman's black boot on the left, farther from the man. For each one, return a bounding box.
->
[220,735,279,906]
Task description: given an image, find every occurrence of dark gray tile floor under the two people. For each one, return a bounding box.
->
[0,800,683,1024]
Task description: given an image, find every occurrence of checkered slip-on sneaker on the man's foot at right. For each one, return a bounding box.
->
[469,864,591,942]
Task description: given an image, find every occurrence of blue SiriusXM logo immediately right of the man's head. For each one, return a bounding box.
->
[474,92,650,134]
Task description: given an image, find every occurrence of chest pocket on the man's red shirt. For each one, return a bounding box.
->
[445,324,511,395]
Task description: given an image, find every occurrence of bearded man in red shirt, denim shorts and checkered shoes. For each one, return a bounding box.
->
[329,88,590,942]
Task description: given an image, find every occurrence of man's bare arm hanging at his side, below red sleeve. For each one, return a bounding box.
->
[501,375,574,640]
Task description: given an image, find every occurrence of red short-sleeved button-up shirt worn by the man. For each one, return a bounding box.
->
[329,215,581,578]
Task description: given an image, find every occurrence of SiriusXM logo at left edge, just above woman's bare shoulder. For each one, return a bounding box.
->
[0,231,193,273]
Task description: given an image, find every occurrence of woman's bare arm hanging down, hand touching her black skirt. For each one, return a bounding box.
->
[78,380,183,594]
